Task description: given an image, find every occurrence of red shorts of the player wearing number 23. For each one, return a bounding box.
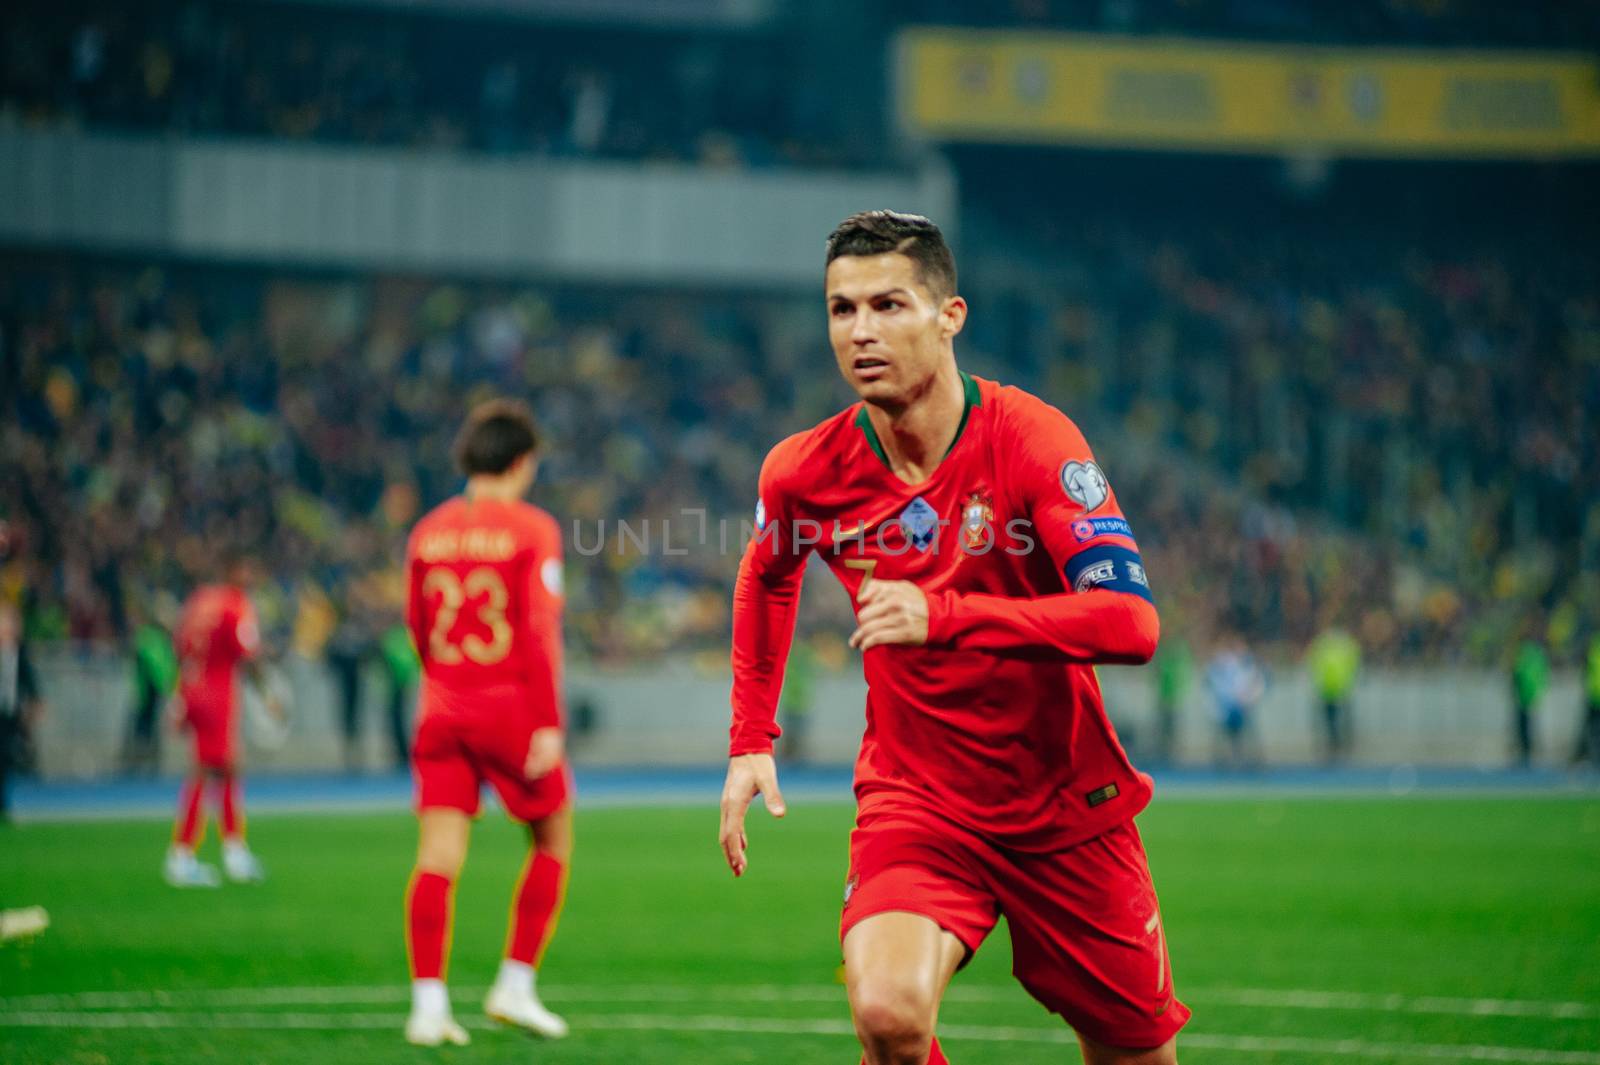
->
[411,697,573,820]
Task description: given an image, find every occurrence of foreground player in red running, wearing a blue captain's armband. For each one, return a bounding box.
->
[722,211,1189,1065]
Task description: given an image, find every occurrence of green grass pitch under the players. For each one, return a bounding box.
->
[0,796,1600,1065]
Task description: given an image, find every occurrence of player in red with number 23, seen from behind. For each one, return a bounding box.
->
[405,400,573,1046]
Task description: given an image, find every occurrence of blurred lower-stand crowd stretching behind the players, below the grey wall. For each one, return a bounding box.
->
[0,203,1600,664]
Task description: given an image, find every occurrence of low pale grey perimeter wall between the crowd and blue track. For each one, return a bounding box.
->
[25,646,1581,779]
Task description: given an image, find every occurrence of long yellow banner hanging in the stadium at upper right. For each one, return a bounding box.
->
[899,29,1600,157]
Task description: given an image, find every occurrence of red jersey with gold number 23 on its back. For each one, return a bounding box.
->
[406,496,565,726]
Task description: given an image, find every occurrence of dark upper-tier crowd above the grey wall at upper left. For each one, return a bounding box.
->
[0,0,883,166]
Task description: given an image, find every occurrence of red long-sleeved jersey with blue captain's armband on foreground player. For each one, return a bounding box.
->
[730,374,1160,851]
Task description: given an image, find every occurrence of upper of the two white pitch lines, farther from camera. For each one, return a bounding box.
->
[0,983,1600,1020]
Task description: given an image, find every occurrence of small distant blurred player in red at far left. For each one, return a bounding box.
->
[163,556,273,888]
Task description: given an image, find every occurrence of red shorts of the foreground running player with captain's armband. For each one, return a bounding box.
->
[840,812,1189,1047]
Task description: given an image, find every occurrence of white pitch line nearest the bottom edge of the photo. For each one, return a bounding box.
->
[0,1011,1600,1065]
